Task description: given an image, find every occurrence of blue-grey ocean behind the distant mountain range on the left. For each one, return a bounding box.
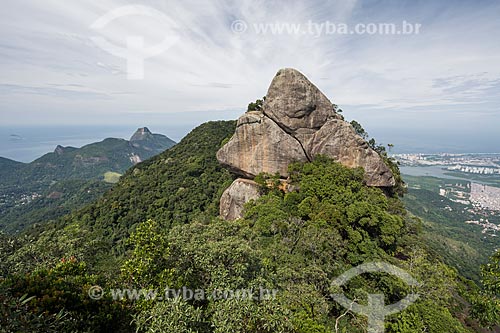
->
[0,126,191,162]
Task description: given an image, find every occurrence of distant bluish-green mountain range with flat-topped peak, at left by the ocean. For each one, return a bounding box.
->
[0,127,175,231]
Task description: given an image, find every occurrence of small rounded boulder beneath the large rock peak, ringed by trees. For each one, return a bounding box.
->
[220,178,260,221]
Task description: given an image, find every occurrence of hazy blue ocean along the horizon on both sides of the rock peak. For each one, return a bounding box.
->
[0,122,500,162]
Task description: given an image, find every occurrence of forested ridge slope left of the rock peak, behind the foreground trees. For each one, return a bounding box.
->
[19,121,235,256]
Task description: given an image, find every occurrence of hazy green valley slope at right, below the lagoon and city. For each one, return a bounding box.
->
[403,175,500,281]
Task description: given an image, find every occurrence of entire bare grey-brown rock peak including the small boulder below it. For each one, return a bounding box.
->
[217,68,395,220]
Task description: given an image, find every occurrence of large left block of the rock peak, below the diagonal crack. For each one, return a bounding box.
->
[217,111,307,178]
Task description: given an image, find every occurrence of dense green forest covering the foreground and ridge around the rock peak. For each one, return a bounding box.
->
[0,121,500,333]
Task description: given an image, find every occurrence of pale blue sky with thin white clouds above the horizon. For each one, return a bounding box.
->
[0,0,500,148]
